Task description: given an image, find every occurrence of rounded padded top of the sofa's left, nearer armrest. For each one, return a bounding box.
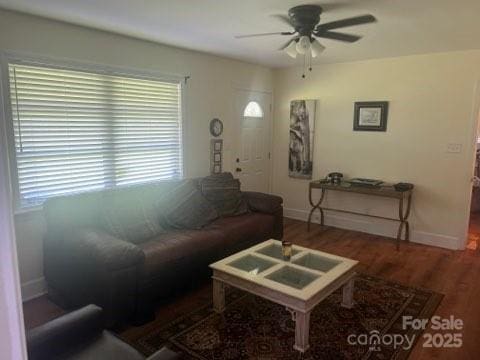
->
[65,228,145,271]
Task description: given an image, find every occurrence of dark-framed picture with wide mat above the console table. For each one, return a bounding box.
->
[353,101,388,131]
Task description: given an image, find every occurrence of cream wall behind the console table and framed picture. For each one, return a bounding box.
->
[273,51,480,248]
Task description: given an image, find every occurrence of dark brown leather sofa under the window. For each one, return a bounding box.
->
[44,177,283,326]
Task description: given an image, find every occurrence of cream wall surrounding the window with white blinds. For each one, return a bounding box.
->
[0,10,273,298]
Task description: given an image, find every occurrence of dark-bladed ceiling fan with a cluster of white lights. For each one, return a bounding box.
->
[235,5,377,77]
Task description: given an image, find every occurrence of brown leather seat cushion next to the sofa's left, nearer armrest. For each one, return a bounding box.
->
[139,229,225,281]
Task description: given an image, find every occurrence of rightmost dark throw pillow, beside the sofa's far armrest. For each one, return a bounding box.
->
[200,173,248,216]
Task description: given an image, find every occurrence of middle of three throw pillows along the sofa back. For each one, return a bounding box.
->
[158,180,218,229]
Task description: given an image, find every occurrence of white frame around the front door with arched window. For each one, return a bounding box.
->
[231,85,274,193]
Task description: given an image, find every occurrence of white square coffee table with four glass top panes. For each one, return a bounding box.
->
[210,239,358,352]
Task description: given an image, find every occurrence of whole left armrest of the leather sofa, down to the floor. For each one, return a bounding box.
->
[44,231,145,327]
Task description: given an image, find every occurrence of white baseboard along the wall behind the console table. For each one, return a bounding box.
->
[283,208,459,250]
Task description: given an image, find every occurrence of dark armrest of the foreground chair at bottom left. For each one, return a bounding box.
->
[27,305,103,359]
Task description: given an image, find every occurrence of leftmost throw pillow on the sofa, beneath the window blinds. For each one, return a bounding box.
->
[101,189,165,244]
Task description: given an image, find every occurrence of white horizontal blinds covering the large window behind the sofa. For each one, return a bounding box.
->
[9,64,182,207]
